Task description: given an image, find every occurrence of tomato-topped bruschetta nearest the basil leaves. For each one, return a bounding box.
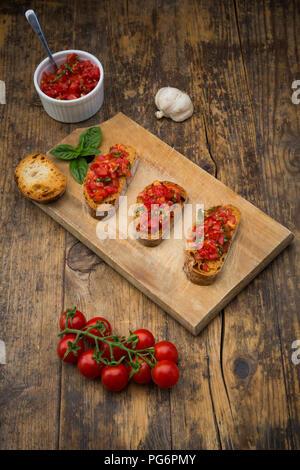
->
[83,144,139,220]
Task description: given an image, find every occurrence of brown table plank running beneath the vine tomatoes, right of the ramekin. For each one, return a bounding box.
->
[60,2,223,449]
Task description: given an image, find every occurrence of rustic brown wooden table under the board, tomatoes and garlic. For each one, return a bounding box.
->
[0,0,300,449]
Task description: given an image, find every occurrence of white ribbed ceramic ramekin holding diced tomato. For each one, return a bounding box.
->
[33,49,104,123]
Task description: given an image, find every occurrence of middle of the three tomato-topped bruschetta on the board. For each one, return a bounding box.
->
[135,180,187,246]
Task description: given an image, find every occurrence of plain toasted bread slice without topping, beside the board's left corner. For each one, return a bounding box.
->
[14,153,67,204]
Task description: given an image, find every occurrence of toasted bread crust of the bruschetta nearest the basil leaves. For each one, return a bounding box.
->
[83,145,139,220]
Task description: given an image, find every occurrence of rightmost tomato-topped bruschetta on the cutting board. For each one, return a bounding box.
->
[183,204,241,285]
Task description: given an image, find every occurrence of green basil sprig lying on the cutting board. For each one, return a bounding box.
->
[50,126,102,184]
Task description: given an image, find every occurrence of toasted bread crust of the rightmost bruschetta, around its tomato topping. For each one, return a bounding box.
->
[183,204,241,286]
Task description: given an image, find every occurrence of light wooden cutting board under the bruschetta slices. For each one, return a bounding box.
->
[37,113,293,335]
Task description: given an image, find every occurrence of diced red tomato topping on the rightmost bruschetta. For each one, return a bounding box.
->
[188,206,236,271]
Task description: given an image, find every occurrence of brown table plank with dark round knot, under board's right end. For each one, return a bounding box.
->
[168,2,299,448]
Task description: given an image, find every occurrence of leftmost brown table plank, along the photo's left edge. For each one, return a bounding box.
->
[0,2,74,449]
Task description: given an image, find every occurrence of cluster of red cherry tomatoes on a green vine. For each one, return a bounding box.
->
[57,307,179,392]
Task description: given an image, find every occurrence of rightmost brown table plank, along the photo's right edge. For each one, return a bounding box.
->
[236,1,300,449]
